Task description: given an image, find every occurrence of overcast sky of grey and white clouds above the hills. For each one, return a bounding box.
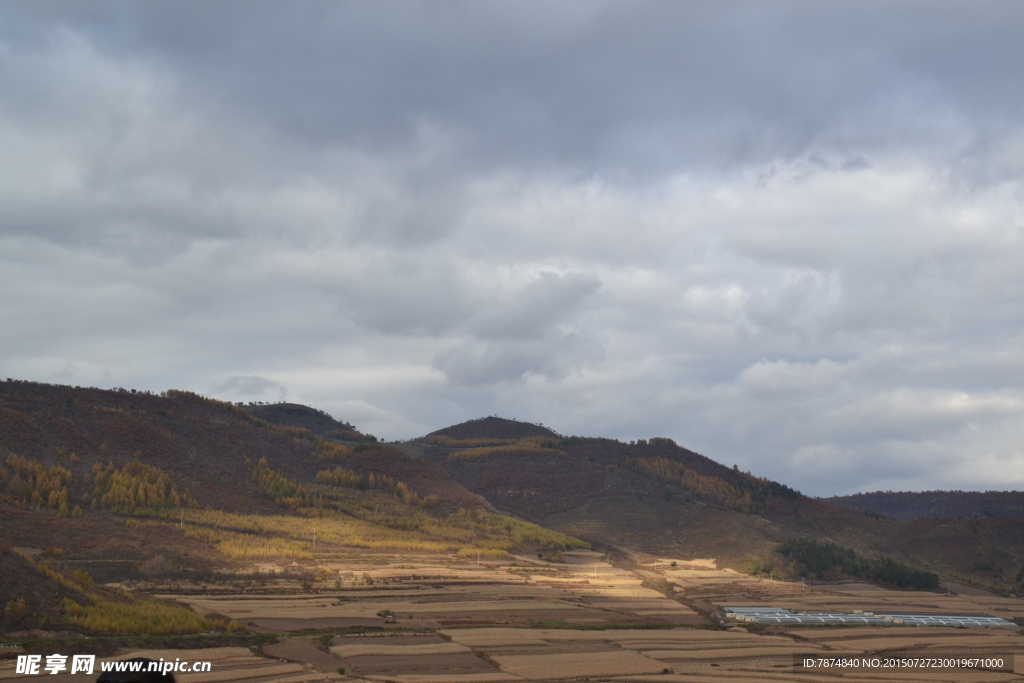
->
[0,0,1024,496]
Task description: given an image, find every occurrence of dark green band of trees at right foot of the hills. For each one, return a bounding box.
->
[778,539,939,591]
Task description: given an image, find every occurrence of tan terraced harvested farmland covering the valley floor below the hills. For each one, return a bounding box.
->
[0,550,1024,683]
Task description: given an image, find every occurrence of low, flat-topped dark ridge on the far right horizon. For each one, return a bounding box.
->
[821,490,1024,521]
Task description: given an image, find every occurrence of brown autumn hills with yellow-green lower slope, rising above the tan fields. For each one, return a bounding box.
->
[6,381,1024,602]
